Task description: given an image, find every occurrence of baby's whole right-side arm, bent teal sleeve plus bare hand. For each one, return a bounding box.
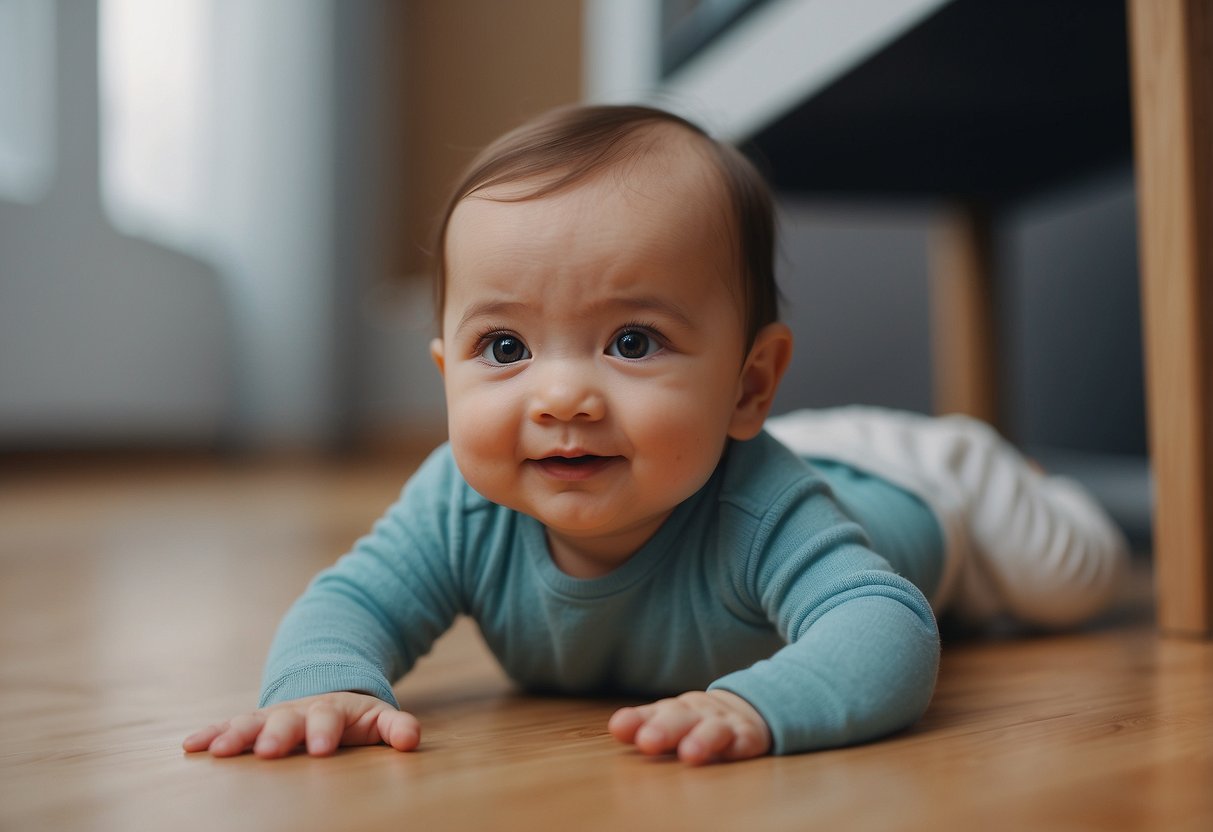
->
[609,480,939,763]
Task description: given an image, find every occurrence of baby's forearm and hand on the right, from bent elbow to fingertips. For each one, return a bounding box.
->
[608,587,939,765]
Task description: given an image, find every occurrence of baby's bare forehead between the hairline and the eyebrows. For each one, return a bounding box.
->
[445,128,744,315]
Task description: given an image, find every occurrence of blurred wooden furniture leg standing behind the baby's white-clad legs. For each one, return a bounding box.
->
[930,206,998,426]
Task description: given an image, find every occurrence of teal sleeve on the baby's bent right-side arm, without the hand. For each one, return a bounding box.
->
[710,439,940,754]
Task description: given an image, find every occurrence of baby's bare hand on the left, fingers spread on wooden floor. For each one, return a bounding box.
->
[182,693,421,759]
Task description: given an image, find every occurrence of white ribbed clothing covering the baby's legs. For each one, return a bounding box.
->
[767,406,1128,627]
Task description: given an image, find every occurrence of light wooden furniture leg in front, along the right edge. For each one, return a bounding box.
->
[1129,0,1213,636]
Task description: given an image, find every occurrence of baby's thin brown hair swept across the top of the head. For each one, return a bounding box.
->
[434,104,779,344]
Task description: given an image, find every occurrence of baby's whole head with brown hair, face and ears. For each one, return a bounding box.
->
[432,107,791,574]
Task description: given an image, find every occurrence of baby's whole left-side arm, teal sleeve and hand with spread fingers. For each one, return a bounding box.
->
[184,454,461,758]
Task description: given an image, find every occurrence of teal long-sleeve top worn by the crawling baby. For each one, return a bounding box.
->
[261,433,944,753]
